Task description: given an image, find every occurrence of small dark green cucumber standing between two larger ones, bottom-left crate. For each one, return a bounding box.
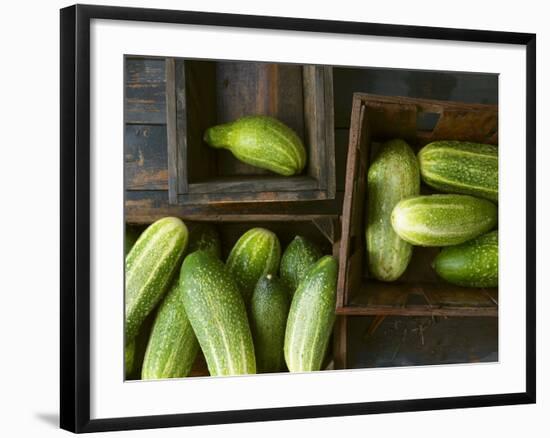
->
[250,274,290,373]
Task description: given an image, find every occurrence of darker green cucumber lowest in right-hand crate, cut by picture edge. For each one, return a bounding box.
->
[433,231,498,287]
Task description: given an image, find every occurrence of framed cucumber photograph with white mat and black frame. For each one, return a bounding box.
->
[61,5,536,432]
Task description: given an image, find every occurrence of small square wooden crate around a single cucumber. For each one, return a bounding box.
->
[166,58,336,205]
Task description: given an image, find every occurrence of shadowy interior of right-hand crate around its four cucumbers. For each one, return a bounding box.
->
[345,102,498,316]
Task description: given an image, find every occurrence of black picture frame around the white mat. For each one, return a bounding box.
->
[60,5,536,433]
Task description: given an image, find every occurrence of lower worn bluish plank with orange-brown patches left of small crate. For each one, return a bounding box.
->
[124,125,168,191]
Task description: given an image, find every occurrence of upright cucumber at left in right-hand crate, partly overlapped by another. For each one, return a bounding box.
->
[366,140,420,281]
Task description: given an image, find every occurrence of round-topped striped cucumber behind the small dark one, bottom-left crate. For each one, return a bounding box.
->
[226,228,281,305]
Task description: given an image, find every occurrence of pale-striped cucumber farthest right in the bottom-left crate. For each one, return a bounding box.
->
[284,256,338,372]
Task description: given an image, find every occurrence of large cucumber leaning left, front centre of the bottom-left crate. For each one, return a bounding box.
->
[179,251,256,376]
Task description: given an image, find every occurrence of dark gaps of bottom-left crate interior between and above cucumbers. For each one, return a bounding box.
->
[126,220,333,380]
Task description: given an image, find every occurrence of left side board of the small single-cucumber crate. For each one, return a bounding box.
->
[166,58,179,204]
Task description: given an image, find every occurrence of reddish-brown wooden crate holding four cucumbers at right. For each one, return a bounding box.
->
[337,94,498,318]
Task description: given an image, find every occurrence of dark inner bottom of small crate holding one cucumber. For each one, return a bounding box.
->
[184,60,316,184]
